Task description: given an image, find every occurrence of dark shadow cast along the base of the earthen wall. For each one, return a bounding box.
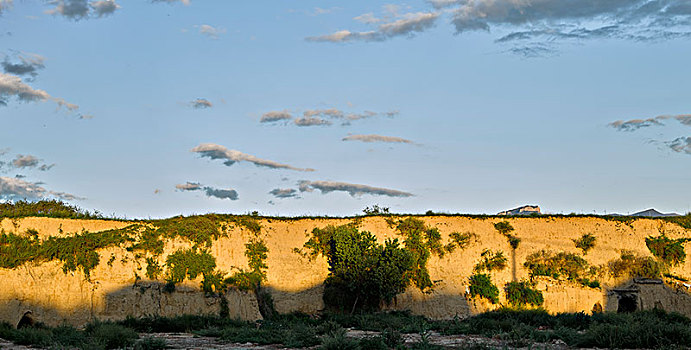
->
[0,279,691,327]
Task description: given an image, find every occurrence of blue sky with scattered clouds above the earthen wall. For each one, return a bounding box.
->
[0,0,691,217]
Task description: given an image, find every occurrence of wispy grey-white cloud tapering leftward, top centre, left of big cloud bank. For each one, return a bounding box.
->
[307,12,440,43]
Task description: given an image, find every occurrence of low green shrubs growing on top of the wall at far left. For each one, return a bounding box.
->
[0,200,104,219]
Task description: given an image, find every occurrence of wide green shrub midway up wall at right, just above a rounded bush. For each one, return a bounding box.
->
[523,250,600,288]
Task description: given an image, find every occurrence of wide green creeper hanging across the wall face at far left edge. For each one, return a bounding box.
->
[0,228,131,279]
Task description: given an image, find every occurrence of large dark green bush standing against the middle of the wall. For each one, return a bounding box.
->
[304,225,414,312]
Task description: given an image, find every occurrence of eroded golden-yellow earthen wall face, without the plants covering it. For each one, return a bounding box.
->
[0,216,691,325]
